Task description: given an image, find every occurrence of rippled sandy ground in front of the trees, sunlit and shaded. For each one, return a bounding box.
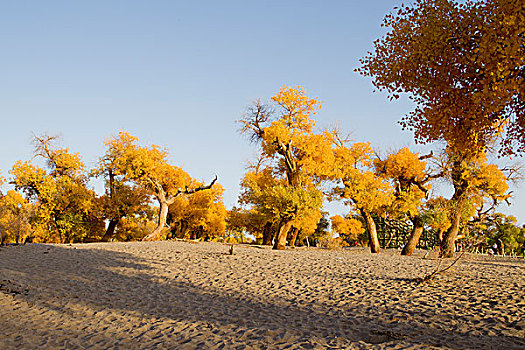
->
[0,242,525,349]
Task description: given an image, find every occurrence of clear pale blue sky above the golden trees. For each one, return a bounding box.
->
[0,0,525,224]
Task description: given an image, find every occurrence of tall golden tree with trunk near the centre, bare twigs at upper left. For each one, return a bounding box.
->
[240,86,332,249]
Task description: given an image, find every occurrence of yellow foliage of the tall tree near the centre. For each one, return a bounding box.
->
[239,86,333,245]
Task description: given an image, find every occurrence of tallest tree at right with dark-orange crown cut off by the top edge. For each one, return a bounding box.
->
[358,0,525,257]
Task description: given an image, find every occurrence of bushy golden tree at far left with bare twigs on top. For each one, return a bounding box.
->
[10,135,103,243]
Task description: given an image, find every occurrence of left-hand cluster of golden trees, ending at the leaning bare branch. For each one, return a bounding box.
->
[0,132,226,243]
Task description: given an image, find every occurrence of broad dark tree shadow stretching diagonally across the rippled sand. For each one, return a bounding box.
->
[0,245,525,349]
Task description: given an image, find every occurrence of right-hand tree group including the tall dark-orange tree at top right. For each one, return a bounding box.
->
[234,0,525,257]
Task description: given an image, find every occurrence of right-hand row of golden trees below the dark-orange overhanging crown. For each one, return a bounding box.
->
[235,87,520,256]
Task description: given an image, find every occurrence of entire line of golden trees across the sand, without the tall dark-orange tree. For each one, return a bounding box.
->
[0,104,524,255]
